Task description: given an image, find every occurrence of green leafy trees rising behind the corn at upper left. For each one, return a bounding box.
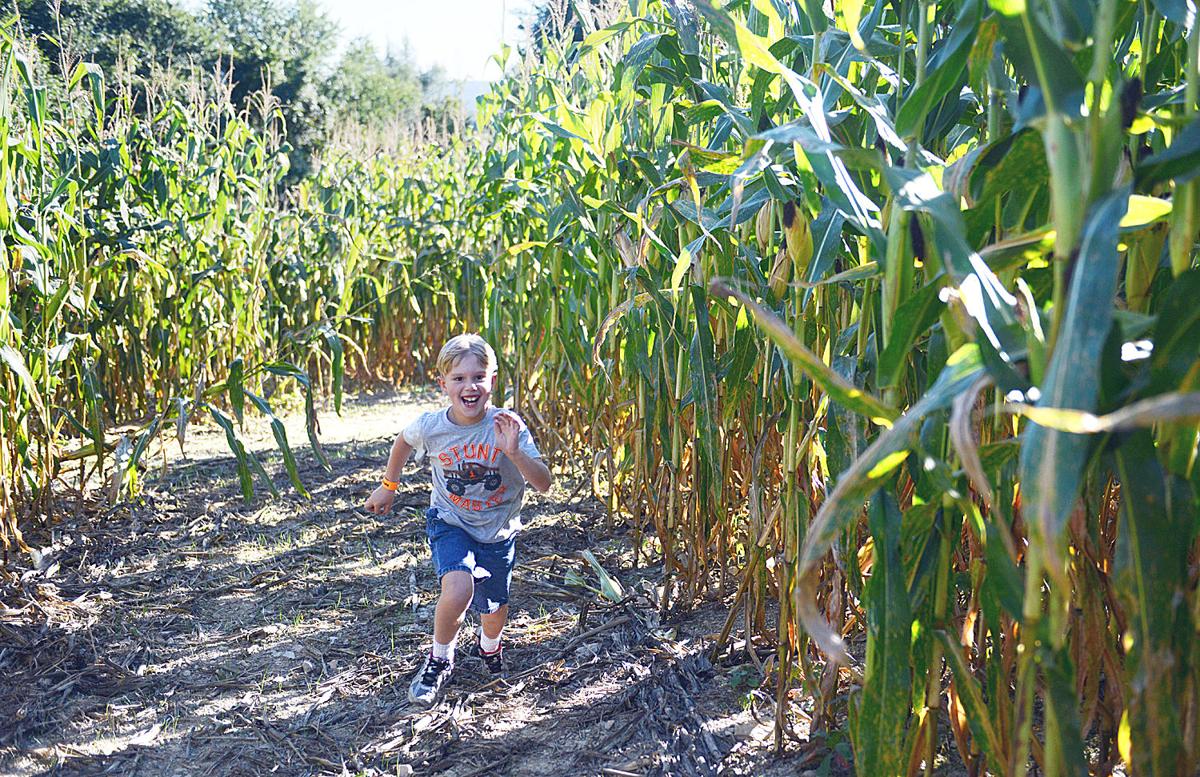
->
[16,0,464,172]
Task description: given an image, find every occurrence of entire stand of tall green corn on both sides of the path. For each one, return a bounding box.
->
[0,0,1200,777]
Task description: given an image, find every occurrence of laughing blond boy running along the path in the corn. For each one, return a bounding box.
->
[366,335,551,704]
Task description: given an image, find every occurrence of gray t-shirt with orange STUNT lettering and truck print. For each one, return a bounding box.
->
[403,408,541,542]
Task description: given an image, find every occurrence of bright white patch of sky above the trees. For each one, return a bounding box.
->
[316,0,534,80]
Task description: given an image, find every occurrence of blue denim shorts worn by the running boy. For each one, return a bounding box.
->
[425,507,517,613]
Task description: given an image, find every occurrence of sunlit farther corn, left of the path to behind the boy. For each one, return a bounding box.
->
[0,22,489,534]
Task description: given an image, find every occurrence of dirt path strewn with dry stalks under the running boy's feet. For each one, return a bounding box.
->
[0,393,846,777]
